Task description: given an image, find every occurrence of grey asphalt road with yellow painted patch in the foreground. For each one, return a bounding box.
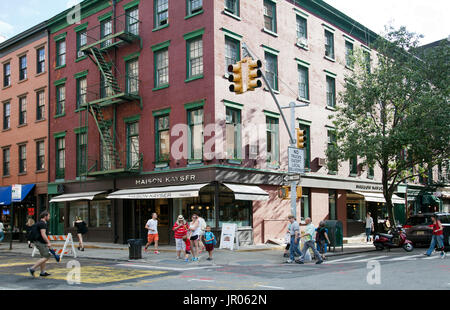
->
[0,249,450,290]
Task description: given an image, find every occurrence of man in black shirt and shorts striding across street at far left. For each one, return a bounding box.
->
[27,211,52,277]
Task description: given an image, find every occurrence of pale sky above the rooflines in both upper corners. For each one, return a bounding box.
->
[0,0,450,44]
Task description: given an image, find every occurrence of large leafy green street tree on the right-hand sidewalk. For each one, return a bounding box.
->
[327,27,450,221]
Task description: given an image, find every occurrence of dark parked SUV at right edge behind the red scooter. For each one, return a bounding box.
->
[403,213,450,246]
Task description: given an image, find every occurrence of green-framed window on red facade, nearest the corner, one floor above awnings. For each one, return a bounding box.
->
[188,109,203,160]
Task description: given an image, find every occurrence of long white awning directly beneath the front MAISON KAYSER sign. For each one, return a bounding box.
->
[106,183,209,199]
